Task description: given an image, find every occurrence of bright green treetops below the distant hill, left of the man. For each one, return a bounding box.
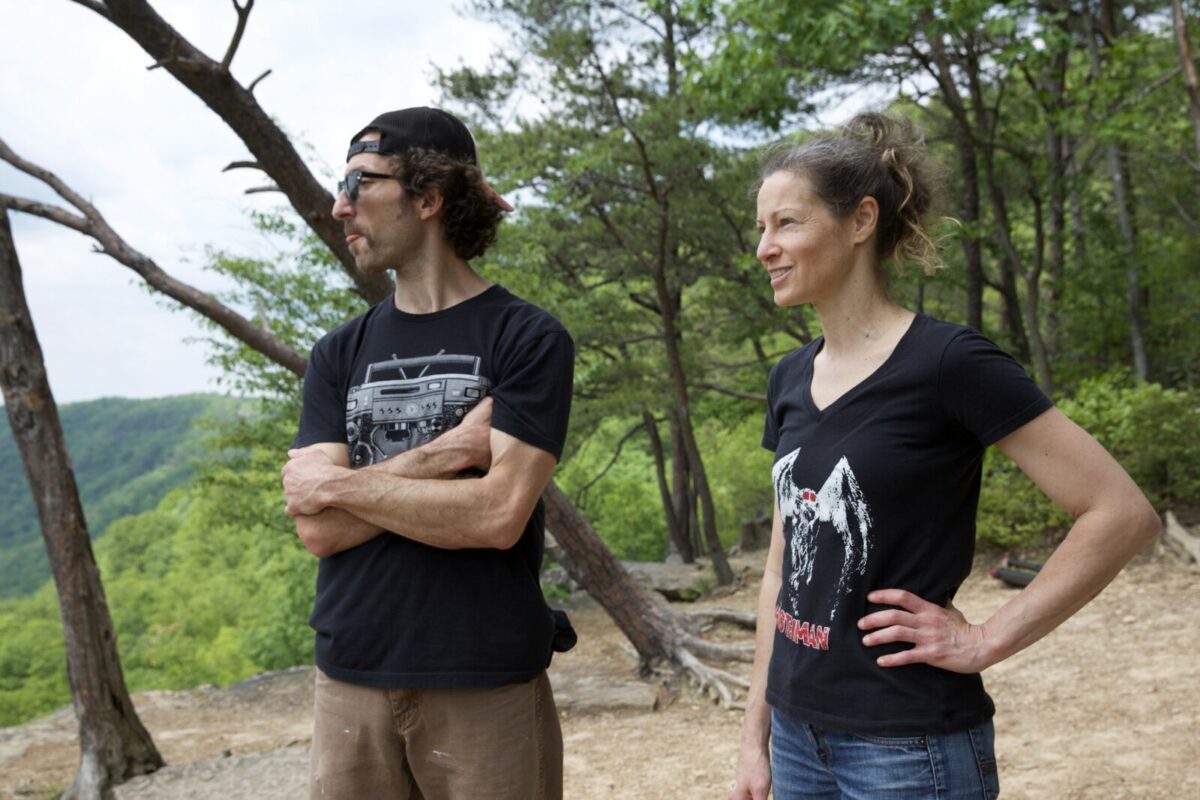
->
[0,403,317,726]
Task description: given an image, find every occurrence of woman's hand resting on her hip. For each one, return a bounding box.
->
[858,589,992,673]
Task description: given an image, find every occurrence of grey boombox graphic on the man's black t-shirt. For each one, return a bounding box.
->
[346,353,492,468]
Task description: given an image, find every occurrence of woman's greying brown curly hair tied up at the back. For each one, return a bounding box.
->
[756,112,942,275]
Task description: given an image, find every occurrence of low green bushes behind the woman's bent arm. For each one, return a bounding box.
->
[978,371,1200,547]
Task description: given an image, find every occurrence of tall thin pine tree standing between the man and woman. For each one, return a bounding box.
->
[442,0,811,583]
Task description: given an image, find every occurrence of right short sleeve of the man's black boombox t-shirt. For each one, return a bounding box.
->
[491,330,575,461]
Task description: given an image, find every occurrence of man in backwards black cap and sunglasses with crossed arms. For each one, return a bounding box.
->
[283,108,574,800]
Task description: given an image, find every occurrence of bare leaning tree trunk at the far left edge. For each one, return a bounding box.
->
[0,210,163,800]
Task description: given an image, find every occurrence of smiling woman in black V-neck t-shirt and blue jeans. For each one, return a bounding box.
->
[730,114,1158,800]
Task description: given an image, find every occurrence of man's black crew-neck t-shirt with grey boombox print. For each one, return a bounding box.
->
[295,285,574,688]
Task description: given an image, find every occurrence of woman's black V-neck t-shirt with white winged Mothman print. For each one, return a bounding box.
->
[763,314,1051,735]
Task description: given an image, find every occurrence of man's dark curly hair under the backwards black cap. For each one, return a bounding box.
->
[388,148,504,260]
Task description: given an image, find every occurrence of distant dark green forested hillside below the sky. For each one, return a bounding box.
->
[0,395,236,599]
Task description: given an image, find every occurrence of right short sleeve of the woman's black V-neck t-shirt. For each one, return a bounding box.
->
[938,330,1054,446]
